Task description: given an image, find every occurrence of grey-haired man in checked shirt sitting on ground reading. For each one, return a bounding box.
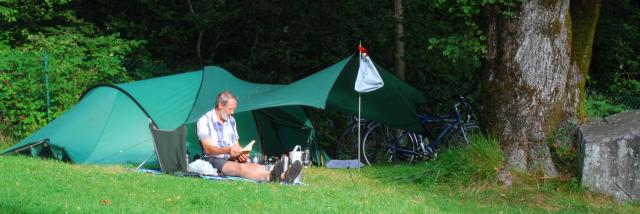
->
[197,91,302,183]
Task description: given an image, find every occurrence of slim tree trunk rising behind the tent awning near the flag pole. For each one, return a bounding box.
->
[393,0,406,80]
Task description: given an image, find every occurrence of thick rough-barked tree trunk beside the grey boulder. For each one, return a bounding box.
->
[480,0,600,184]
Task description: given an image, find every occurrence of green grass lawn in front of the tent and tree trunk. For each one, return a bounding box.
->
[0,138,640,213]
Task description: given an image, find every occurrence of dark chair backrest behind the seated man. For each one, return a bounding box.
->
[149,123,187,173]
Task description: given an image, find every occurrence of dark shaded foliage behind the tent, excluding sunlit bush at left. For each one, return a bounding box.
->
[75,0,518,101]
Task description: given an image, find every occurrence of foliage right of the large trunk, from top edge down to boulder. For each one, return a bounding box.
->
[585,0,640,117]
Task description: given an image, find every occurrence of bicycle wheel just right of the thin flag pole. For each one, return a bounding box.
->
[362,125,389,165]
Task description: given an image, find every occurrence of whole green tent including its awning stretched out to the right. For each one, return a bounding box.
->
[3,56,424,164]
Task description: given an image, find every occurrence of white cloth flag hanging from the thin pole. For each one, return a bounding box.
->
[355,45,384,93]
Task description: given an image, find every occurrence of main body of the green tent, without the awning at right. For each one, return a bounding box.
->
[4,67,313,164]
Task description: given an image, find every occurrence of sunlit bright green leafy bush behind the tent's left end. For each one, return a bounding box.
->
[0,26,141,138]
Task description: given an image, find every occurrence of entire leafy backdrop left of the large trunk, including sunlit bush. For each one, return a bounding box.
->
[0,0,517,138]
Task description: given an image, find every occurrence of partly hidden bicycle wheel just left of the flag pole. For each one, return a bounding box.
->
[335,123,366,160]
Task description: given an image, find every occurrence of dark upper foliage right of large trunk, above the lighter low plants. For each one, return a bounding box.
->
[589,0,640,97]
